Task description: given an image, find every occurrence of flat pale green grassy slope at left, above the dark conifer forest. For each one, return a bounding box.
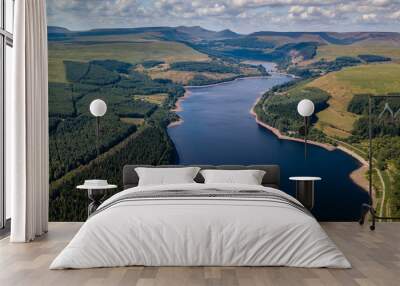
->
[49,41,208,82]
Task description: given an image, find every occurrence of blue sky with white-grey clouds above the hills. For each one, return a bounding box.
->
[47,0,400,34]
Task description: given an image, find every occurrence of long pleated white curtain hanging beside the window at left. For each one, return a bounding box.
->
[6,0,49,242]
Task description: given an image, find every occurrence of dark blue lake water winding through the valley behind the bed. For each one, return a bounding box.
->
[168,65,368,221]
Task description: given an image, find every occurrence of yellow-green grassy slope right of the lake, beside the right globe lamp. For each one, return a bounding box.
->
[308,63,400,137]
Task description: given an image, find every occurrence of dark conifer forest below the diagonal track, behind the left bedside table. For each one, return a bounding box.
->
[49,123,175,221]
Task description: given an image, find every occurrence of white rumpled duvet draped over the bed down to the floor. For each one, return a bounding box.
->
[50,184,351,269]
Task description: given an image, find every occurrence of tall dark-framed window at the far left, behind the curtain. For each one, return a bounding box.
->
[0,0,14,228]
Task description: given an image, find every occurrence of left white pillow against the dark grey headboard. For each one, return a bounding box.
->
[135,167,200,186]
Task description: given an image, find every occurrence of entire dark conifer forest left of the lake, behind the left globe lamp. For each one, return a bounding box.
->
[49,57,184,220]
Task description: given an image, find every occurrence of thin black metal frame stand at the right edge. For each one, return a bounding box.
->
[359,95,400,230]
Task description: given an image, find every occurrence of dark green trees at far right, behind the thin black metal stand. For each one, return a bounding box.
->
[348,93,400,217]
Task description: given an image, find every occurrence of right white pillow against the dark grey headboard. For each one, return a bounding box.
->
[200,170,265,185]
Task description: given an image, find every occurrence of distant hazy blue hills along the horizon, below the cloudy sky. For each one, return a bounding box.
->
[48,26,400,67]
